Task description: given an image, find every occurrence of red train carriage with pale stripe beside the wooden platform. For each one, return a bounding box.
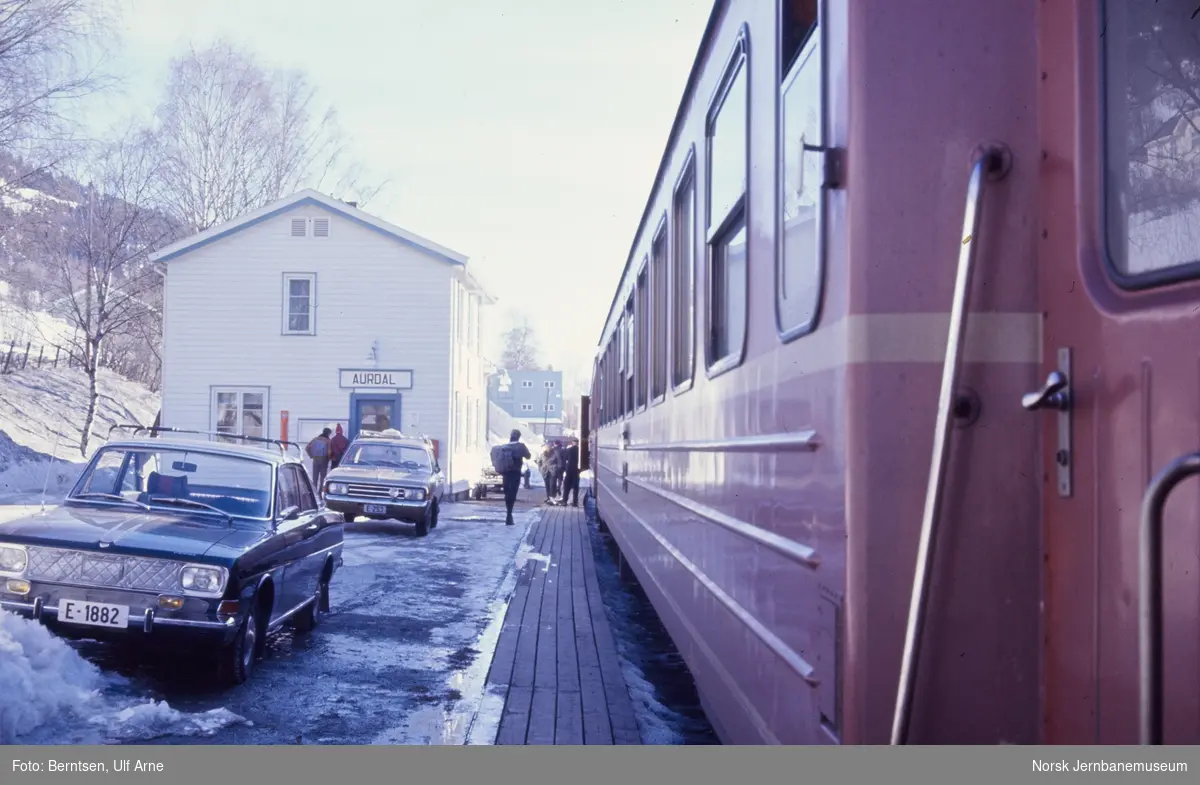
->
[590,0,1200,744]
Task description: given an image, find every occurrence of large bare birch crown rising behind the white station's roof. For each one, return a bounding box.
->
[149,41,382,232]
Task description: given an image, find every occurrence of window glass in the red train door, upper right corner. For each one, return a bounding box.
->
[1103,0,1200,288]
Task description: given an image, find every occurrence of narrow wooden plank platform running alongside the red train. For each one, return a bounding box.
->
[487,499,642,744]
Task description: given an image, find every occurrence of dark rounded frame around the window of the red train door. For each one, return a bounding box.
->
[1093,0,1200,294]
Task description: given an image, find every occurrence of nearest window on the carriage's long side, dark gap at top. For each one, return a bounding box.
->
[775,0,823,340]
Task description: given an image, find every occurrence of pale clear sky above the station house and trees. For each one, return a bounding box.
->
[98,0,712,391]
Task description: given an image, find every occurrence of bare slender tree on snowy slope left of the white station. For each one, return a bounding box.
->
[46,133,170,457]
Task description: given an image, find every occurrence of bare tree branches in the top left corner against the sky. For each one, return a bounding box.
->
[0,0,115,191]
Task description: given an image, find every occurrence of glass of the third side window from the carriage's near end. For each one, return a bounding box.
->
[671,161,696,388]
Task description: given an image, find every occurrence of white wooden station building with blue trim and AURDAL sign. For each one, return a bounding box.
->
[151,191,492,493]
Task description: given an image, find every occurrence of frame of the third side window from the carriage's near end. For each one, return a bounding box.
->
[667,144,700,395]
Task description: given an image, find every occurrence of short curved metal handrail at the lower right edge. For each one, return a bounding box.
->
[1138,453,1200,745]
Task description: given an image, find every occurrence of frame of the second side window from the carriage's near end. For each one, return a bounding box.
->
[704,24,754,379]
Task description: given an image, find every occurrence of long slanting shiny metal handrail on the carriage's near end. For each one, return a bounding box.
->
[892,143,1012,744]
